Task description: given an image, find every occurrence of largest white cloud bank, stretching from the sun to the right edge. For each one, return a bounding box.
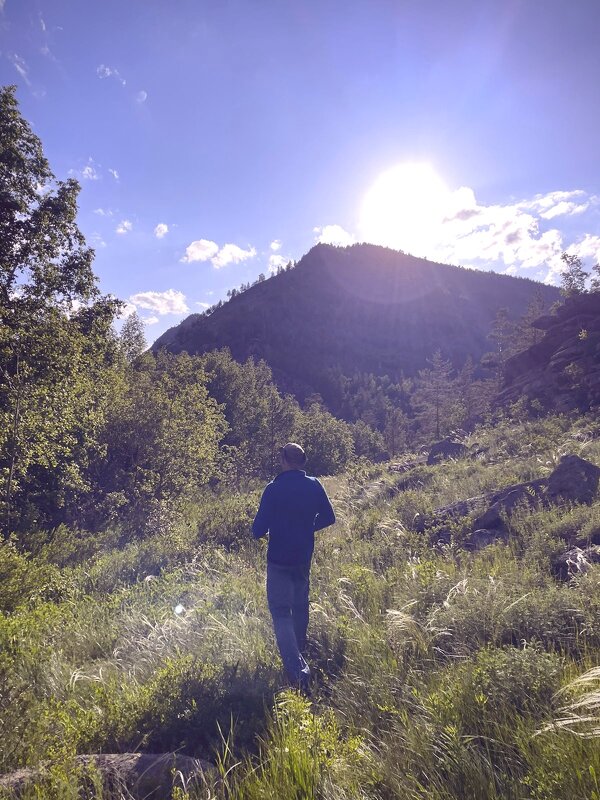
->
[356,175,600,283]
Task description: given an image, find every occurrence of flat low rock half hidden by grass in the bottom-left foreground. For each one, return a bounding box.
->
[0,753,214,800]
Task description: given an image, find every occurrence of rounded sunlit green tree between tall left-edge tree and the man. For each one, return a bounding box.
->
[96,351,227,522]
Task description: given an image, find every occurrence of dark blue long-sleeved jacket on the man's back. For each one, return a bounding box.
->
[252,469,335,566]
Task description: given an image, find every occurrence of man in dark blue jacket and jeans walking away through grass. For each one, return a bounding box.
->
[252,442,335,691]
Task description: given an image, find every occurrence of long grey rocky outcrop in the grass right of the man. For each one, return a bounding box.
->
[413,455,600,549]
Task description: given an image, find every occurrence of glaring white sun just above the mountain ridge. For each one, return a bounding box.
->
[358,162,451,256]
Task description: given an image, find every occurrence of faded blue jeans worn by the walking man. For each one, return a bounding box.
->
[267,562,310,689]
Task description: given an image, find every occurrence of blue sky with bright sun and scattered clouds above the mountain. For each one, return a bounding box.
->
[0,0,600,341]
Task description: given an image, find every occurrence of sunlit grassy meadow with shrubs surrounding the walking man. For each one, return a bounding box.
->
[0,416,600,800]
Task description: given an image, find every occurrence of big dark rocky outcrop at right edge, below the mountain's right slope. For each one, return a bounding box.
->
[495,292,600,412]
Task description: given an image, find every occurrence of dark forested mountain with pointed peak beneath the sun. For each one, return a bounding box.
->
[153,244,559,400]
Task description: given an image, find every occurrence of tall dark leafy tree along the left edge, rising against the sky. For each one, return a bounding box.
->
[0,86,119,532]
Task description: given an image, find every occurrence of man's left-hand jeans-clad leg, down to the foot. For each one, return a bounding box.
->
[267,564,310,689]
